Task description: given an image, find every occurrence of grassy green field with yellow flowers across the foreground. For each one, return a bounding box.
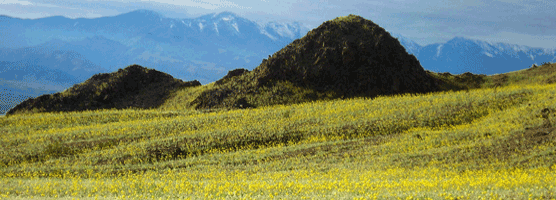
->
[0,65,556,199]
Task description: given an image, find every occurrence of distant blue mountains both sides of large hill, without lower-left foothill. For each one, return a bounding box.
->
[0,10,556,83]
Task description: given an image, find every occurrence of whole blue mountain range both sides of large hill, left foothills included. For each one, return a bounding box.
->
[0,10,556,114]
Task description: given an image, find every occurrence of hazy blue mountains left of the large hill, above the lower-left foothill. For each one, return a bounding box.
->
[0,10,310,84]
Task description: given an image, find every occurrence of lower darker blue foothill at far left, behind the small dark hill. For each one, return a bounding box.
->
[0,45,106,114]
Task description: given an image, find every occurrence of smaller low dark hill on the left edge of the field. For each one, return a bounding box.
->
[6,65,201,115]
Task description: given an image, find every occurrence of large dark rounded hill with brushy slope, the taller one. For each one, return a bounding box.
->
[191,15,439,108]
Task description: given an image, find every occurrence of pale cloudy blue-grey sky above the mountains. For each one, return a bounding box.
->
[0,0,556,48]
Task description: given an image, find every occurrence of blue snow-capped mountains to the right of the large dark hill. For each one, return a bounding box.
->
[393,34,556,75]
